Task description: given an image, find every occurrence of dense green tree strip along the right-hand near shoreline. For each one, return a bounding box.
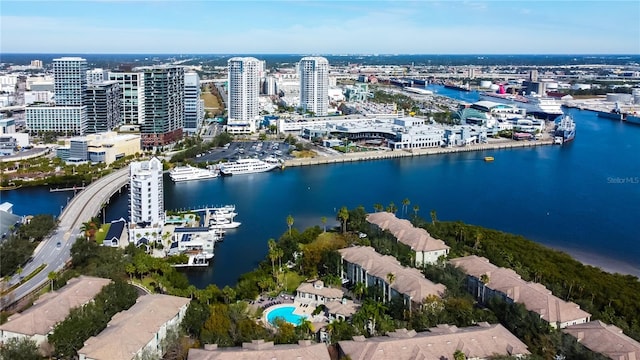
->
[417,220,640,340]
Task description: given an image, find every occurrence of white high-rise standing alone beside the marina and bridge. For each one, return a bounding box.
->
[129,157,164,226]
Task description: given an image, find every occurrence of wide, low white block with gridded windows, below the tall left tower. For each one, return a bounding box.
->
[25,105,87,135]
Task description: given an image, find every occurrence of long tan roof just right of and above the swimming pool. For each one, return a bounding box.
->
[338,246,446,302]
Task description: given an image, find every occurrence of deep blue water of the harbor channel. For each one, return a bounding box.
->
[6,87,640,287]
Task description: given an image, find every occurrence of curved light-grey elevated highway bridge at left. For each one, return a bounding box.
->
[4,166,129,305]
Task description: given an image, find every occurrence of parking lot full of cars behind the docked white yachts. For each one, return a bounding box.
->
[194,141,291,164]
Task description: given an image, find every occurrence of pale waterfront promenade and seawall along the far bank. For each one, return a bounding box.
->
[284,139,553,167]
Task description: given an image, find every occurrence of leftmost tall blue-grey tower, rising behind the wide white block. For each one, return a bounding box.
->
[53,57,87,106]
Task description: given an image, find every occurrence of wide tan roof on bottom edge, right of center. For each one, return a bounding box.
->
[338,323,529,360]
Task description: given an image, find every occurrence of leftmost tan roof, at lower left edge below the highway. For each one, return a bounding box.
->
[0,275,111,336]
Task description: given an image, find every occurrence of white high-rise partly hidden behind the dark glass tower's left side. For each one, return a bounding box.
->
[109,72,144,124]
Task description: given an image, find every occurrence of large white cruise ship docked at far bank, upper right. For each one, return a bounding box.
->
[479,85,563,120]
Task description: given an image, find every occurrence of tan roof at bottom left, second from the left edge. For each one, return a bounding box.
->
[78,294,190,360]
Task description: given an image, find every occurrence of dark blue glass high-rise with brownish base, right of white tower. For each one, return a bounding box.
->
[140,66,184,149]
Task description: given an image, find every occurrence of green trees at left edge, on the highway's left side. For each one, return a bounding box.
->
[0,215,57,276]
